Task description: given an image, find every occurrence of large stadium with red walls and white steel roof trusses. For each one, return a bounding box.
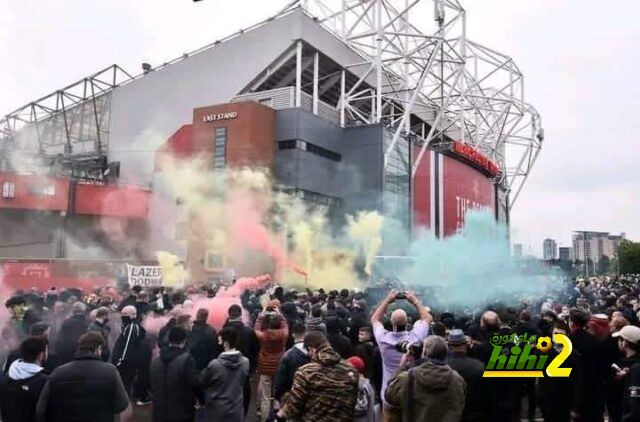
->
[0,0,543,281]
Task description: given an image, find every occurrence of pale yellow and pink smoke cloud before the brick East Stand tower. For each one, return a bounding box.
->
[158,152,383,289]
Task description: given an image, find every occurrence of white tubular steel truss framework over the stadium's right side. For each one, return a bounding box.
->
[282,0,544,209]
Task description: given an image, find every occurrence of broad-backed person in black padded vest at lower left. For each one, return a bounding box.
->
[36,332,133,422]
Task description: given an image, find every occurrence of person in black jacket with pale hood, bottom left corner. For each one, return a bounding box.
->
[0,337,48,422]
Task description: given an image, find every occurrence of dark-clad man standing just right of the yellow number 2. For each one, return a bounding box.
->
[569,309,604,421]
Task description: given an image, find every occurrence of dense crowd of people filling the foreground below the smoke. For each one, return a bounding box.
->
[0,276,640,422]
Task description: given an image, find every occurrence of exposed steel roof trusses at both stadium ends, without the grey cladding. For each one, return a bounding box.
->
[0,0,543,208]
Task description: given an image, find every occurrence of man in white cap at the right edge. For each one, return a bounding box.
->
[612,325,640,421]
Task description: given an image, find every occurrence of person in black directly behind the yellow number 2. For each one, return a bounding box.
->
[537,320,584,422]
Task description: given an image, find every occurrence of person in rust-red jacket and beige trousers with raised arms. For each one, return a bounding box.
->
[255,300,289,420]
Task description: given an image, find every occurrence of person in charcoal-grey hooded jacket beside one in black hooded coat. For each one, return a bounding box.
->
[200,327,250,422]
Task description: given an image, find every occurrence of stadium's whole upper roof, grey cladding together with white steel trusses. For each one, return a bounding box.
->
[0,0,543,208]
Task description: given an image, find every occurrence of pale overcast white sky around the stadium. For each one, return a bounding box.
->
[0,0,640,256]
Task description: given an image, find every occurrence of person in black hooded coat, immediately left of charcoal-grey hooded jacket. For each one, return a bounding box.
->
[150,326,199,422]
